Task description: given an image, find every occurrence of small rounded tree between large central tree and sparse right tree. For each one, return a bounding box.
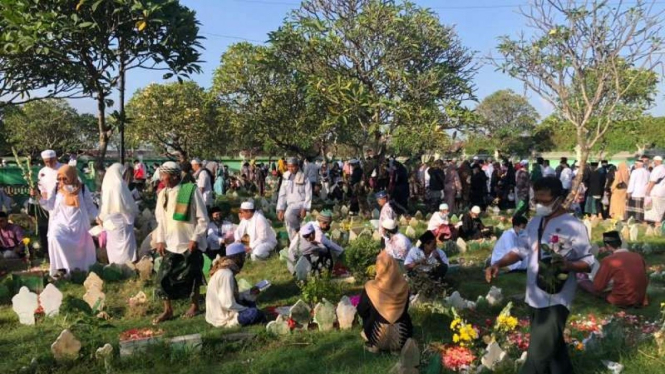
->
[473,90,539,155]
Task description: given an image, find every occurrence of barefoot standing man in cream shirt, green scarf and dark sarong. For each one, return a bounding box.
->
[152,161,208,324]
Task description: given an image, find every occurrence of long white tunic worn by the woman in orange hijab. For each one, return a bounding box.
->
[40,190,97,275]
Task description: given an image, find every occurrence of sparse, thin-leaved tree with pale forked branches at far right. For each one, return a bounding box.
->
[493,0,663,203]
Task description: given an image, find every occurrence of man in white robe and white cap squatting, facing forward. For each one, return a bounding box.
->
[235,201,277,261]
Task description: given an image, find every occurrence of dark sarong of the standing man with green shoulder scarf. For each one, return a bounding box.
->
[155,250,203,300]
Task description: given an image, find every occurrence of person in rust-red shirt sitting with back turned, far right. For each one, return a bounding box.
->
[578,231,649,308]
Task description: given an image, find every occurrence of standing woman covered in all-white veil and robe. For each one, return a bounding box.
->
[99,163,138,264]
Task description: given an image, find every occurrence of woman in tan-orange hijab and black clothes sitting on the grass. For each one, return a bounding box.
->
[358,251,413,353]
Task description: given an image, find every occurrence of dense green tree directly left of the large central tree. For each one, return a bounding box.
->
[212,43,331,157]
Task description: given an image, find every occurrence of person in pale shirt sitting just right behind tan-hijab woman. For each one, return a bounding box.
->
[404,230,449,280]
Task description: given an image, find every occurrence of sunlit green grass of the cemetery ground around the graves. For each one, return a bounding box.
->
[0,222,665,374]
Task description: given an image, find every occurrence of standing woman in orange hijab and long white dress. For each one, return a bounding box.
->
[33,165,97,278]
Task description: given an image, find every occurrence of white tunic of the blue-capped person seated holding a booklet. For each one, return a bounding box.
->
[206,269,253,327]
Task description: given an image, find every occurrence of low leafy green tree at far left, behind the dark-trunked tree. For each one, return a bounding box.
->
[4,99,88,157]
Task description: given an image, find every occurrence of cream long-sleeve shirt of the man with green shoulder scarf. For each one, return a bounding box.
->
[153,185,208,253]
